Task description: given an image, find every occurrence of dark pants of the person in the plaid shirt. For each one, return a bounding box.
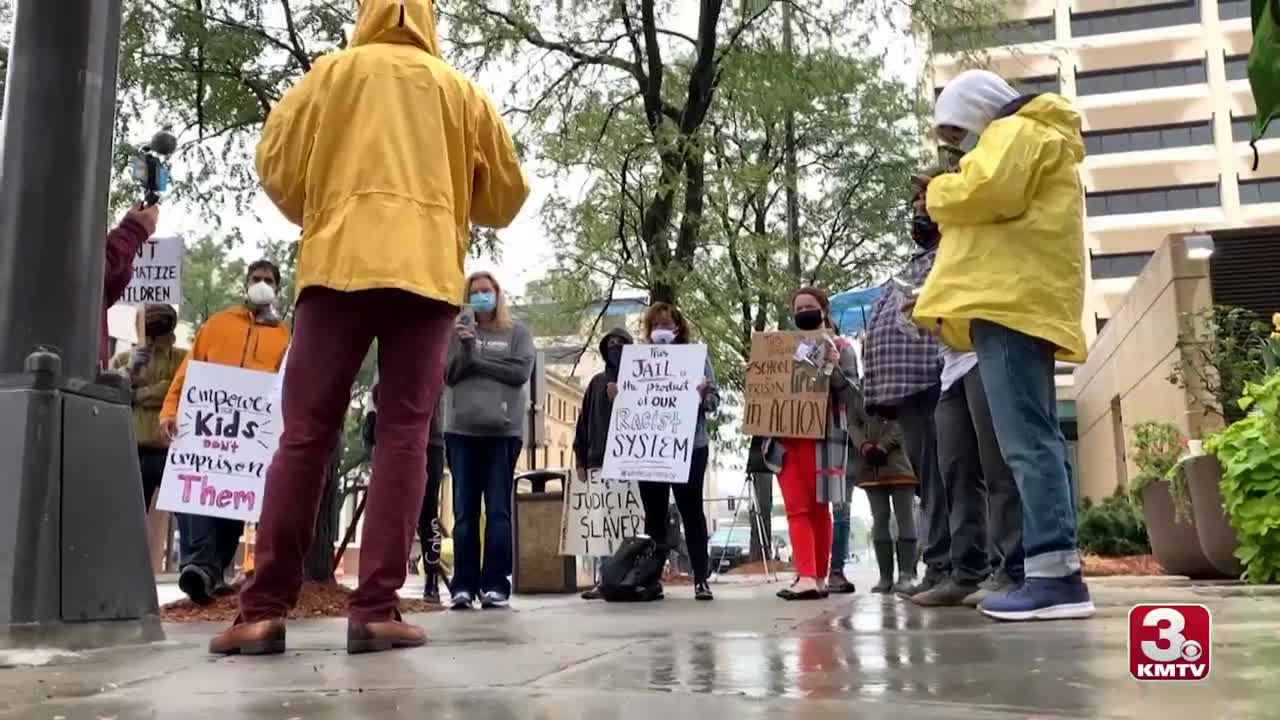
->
[897,386,951,575]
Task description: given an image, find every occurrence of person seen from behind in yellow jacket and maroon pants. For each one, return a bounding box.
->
[217,0,529,655]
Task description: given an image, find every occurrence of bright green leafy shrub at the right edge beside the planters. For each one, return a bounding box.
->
[1204,372,1280,583]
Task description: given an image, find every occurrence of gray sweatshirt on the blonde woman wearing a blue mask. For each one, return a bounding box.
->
[444,323,536,438]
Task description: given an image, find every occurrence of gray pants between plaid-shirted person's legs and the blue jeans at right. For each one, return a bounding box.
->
[937,368,1023,584]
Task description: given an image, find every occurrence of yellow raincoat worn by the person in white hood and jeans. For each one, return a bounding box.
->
[914,94,1087,363]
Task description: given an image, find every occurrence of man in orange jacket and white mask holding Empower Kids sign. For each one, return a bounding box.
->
[160,260,289,605]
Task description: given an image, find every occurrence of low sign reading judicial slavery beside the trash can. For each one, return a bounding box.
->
[561,470,644,557]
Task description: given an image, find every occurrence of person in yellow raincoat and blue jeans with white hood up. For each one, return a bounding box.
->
[914,70,1094,620]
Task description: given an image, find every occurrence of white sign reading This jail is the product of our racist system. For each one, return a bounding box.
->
[602,345,707,483]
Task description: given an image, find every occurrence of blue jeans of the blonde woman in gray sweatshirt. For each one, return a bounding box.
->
[444,434,524,596]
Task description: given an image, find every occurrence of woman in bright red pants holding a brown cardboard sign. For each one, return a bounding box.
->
[763,287,858,600]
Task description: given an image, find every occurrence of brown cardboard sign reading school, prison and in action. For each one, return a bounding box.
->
[742,332,831,439]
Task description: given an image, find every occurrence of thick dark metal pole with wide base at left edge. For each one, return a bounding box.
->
[0,0,163,647]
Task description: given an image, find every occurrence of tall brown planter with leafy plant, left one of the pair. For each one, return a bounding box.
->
[1130,421,1220,578]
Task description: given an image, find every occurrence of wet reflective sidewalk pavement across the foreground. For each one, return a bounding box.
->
[0,578,1280,720]
